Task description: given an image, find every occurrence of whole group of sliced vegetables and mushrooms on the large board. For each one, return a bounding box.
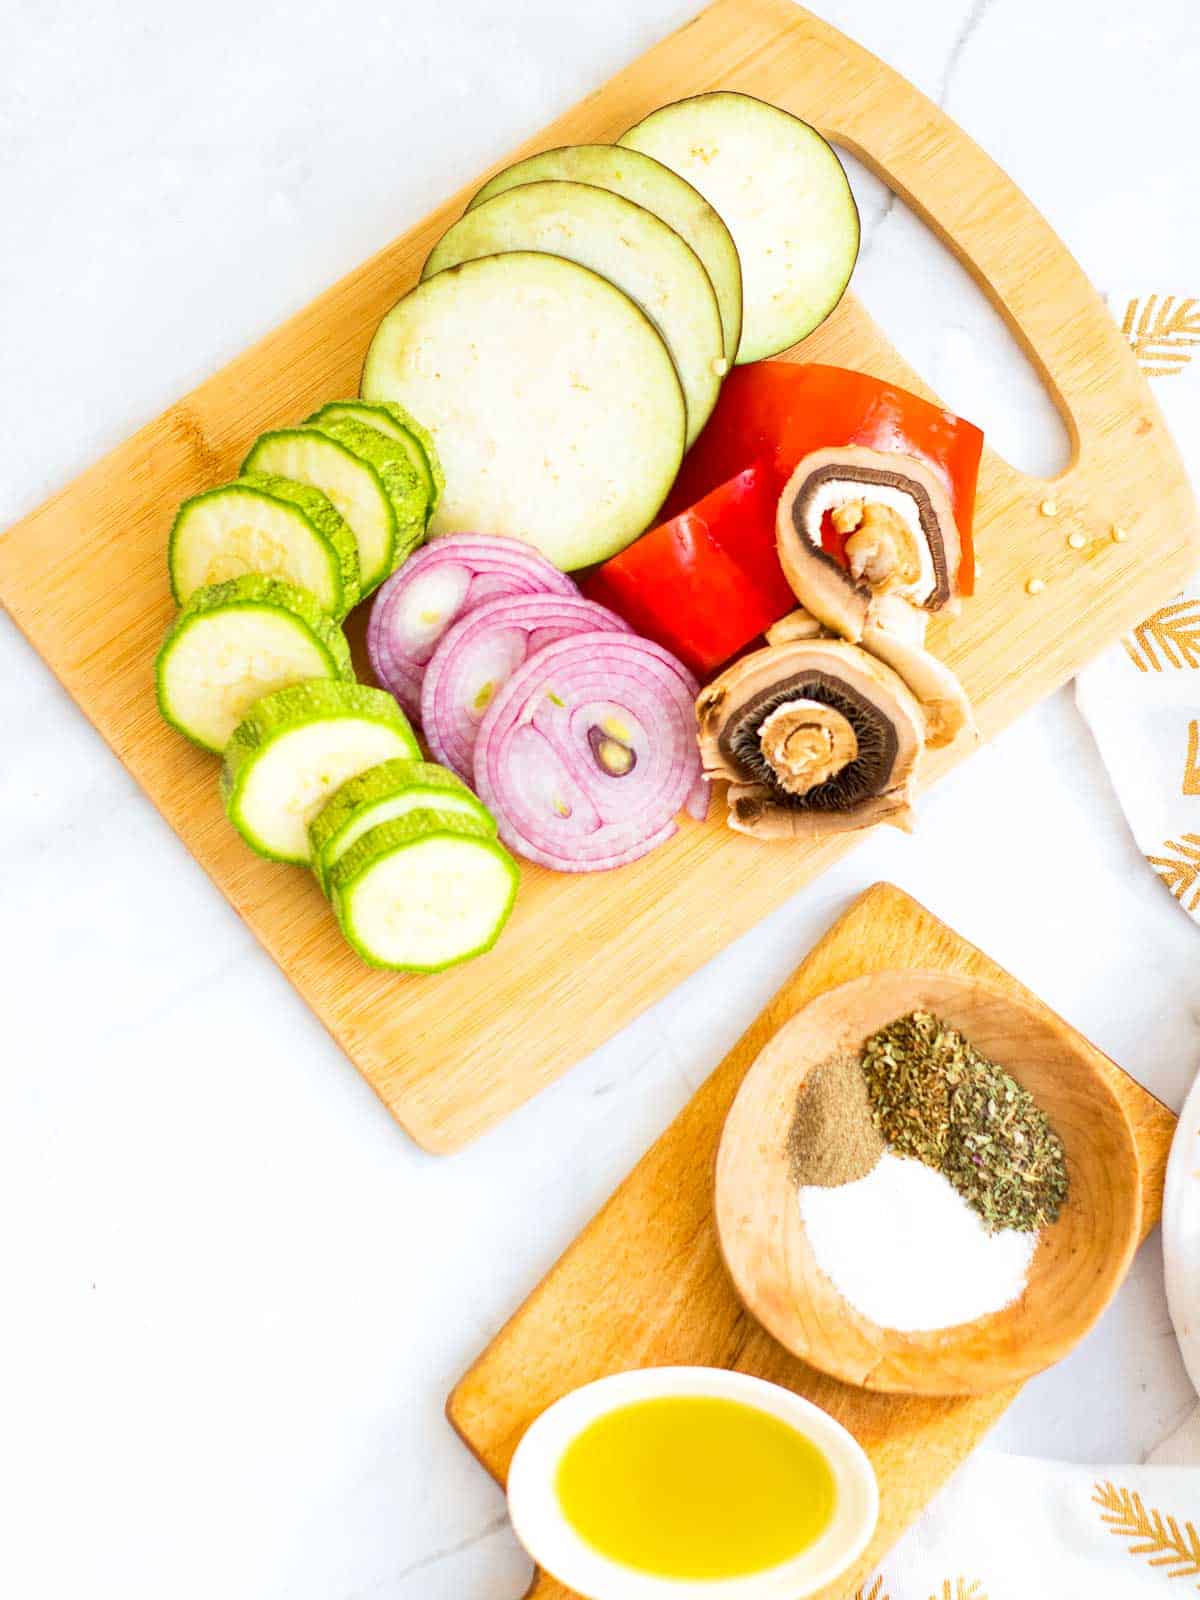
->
[157,93,982,973]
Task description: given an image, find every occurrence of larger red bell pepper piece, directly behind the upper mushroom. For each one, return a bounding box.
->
[664,362,984,595]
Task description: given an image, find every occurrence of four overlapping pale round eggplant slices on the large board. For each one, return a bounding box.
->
[363,93,859,571]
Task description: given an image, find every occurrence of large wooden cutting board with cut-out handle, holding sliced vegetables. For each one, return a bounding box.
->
[0,0,1197,1150]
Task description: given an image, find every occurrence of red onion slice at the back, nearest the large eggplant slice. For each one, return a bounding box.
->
[366,533,579,717]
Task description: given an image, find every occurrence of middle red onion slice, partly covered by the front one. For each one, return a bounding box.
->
[421,594,630,782]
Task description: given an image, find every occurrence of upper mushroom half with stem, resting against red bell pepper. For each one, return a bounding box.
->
[776,445,962,643]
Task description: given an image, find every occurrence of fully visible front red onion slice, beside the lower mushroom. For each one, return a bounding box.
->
[474,632,701,872]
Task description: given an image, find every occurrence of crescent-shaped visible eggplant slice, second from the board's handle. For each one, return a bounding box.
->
[467,144,742,366]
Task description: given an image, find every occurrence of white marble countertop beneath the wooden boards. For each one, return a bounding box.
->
[0,0,1200,1600]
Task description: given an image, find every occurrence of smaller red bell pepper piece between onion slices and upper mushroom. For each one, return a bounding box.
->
[582,466,795,677]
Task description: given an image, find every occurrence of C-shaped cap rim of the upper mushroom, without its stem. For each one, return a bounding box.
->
[776,445,962,642]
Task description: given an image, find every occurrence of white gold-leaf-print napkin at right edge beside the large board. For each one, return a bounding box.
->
[1075,291,1200,920]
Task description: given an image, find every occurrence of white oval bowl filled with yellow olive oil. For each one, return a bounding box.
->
[509,1366,878,1600]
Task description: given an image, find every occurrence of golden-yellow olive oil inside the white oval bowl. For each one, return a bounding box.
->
[555,1395,835,1578]
